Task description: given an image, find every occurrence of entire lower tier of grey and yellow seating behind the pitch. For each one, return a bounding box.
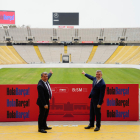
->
[0,45,140,65]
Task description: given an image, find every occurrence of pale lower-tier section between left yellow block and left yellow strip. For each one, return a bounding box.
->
[14,45,41,63]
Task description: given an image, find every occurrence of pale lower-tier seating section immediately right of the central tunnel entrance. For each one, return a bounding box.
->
[67,45,93,63]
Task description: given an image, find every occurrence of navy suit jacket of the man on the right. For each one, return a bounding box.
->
[85,74,106,105]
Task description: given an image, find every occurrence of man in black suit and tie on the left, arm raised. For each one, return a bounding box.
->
[37,70,53,133]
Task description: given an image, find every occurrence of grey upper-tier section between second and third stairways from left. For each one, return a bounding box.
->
[31,28,53,42]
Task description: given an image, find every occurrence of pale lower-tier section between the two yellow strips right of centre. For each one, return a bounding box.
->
[90,45,118,64]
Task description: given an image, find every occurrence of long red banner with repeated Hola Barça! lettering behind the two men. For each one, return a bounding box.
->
[0,84,139,122]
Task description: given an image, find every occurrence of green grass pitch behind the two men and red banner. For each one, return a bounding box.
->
[0,68,140,85]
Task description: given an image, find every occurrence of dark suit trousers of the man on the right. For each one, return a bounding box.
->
[89,98,101,128]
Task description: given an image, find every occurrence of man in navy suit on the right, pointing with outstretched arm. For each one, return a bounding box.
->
[82,70,106,131]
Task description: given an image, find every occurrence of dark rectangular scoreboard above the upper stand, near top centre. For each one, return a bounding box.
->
[52,13,79,25]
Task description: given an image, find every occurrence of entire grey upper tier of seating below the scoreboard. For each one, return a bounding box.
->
[0,28,140,43]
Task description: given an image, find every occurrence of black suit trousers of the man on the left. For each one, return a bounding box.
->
[38,106,49,129]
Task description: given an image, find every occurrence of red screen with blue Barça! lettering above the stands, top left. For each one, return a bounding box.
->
[0,11,15,24]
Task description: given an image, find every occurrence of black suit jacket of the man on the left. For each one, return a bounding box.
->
[37,73,52,107]
